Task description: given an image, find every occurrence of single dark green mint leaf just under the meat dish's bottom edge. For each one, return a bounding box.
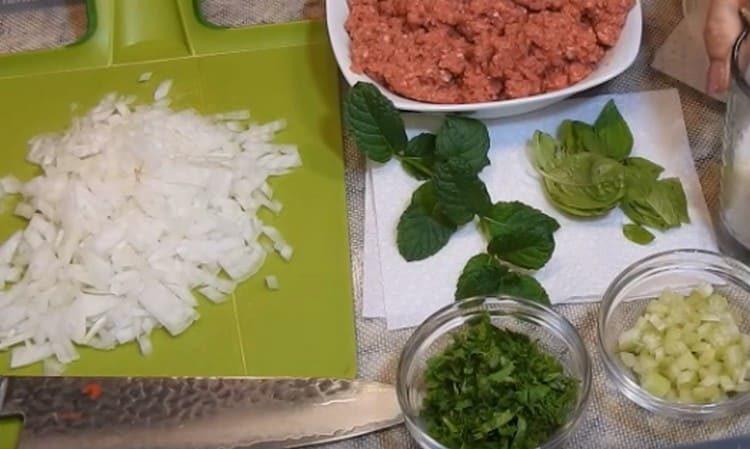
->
[435,116,490,173]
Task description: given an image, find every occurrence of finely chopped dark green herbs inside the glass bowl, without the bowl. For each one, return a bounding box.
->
[421,314,578,449]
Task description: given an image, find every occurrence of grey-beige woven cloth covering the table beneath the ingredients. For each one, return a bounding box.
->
[0,0,750,449]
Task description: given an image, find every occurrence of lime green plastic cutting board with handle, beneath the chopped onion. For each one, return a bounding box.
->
[0,0,356,449]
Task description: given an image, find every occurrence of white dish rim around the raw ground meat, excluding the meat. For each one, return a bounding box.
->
[326,0,643,118]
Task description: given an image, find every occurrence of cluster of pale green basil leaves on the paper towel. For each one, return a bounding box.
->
[531,100,690,244]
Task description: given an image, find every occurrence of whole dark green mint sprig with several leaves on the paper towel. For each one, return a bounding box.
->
[344,83,560,303]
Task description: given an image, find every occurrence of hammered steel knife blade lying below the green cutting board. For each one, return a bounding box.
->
[0,377,402,449]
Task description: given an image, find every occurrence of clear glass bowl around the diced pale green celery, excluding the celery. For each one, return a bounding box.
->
[598,249,750,420]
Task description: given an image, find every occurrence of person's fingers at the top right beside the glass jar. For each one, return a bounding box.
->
[703,0,748,93]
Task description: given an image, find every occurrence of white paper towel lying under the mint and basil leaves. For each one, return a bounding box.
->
[364,90,716,329]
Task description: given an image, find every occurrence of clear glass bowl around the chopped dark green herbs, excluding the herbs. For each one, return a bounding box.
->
[396,297,591,449]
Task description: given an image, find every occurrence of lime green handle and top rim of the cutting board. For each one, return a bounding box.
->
[0,0,326,79]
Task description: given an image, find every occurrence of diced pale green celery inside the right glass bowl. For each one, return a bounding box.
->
[619,285,750,404]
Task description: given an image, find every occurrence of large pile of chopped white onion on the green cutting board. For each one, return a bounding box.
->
[0,81,301,370]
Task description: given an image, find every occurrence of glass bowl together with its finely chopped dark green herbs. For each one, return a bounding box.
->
[397,297,591,449]
